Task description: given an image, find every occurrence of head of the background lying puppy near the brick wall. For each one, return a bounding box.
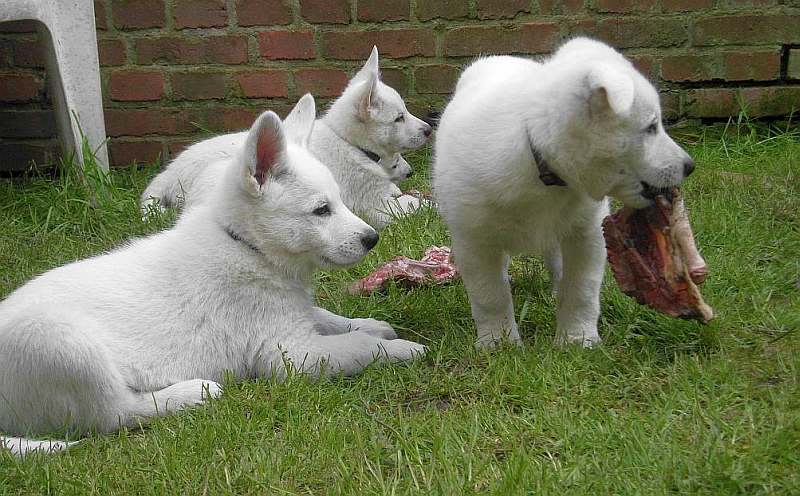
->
[332,47,432,156]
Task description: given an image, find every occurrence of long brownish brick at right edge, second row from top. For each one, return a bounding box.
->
[692,14,800,46]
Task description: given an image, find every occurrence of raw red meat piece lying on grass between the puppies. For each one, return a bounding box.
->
[348,246,458,295]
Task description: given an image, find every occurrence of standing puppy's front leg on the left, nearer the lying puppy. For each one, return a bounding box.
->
[453,237,520,348]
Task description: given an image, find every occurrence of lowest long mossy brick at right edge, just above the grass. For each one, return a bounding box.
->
[684,86,800,118]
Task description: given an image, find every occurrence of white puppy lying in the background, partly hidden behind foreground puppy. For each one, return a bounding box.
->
[142,48,431,229]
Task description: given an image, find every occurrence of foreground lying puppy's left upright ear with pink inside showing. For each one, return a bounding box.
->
[242,110,286,193]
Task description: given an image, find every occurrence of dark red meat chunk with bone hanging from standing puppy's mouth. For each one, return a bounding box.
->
[603,188,714,323]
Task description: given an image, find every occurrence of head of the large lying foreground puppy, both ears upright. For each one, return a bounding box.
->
[223,94,378,267]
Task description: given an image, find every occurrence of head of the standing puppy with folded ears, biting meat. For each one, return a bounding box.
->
[554,39,694,208]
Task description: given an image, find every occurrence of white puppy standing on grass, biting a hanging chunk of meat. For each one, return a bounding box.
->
[433,38,694,346]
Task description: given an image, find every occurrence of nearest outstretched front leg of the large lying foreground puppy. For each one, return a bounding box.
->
[280,329,427,375]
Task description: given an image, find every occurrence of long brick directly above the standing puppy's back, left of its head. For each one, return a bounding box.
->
[444,22,559,56]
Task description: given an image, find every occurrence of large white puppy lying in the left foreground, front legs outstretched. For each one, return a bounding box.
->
[0,96,425,453]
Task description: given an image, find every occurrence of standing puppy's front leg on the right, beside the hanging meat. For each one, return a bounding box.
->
[556,225,605,347]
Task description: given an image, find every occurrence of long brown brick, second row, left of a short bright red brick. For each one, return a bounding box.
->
[136,36,247,64]
